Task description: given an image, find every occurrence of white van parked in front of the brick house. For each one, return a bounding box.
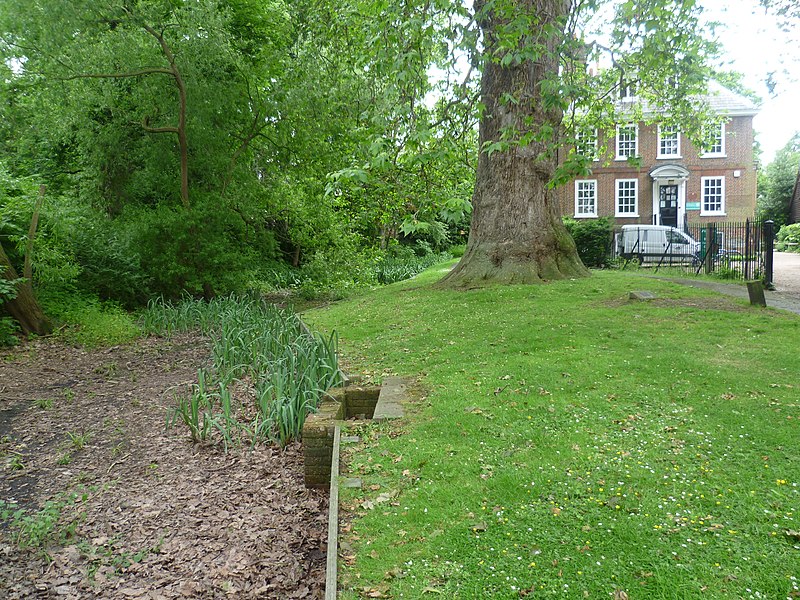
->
[617,225,700,262]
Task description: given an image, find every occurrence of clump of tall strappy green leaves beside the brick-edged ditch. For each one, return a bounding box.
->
[142,296,341,449]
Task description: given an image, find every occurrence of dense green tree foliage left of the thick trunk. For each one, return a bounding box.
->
[0,0,475,304]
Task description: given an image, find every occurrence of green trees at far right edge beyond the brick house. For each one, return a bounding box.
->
[757,133,800,227]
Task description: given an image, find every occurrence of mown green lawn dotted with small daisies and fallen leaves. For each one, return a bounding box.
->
[304,266,800,599]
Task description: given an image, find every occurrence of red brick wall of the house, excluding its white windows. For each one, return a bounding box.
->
[558,117,756,225]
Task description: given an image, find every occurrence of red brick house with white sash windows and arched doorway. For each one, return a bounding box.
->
[558,83,758,228]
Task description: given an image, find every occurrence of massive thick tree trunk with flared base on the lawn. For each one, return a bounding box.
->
[440,0,589,287]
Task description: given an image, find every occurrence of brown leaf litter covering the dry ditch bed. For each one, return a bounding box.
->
[0,335,327,599]
